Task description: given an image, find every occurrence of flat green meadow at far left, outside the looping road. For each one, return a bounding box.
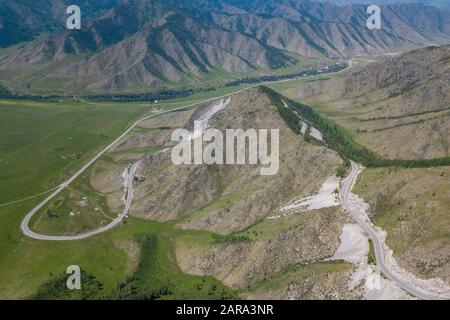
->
[0,100,148,203]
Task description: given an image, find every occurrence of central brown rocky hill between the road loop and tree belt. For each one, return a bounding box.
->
[128,89,340,234]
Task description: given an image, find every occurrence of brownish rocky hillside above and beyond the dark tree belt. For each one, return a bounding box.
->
[288,46,450,159]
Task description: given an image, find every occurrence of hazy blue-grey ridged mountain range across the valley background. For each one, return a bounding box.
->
[0,0,450,92]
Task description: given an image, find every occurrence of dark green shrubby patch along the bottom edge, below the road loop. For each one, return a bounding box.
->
[32,230,238,300]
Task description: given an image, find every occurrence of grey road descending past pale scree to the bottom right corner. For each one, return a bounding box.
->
[339,161,444,300]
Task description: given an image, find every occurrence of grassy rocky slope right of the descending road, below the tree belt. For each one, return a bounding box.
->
[356,167,450,284]
